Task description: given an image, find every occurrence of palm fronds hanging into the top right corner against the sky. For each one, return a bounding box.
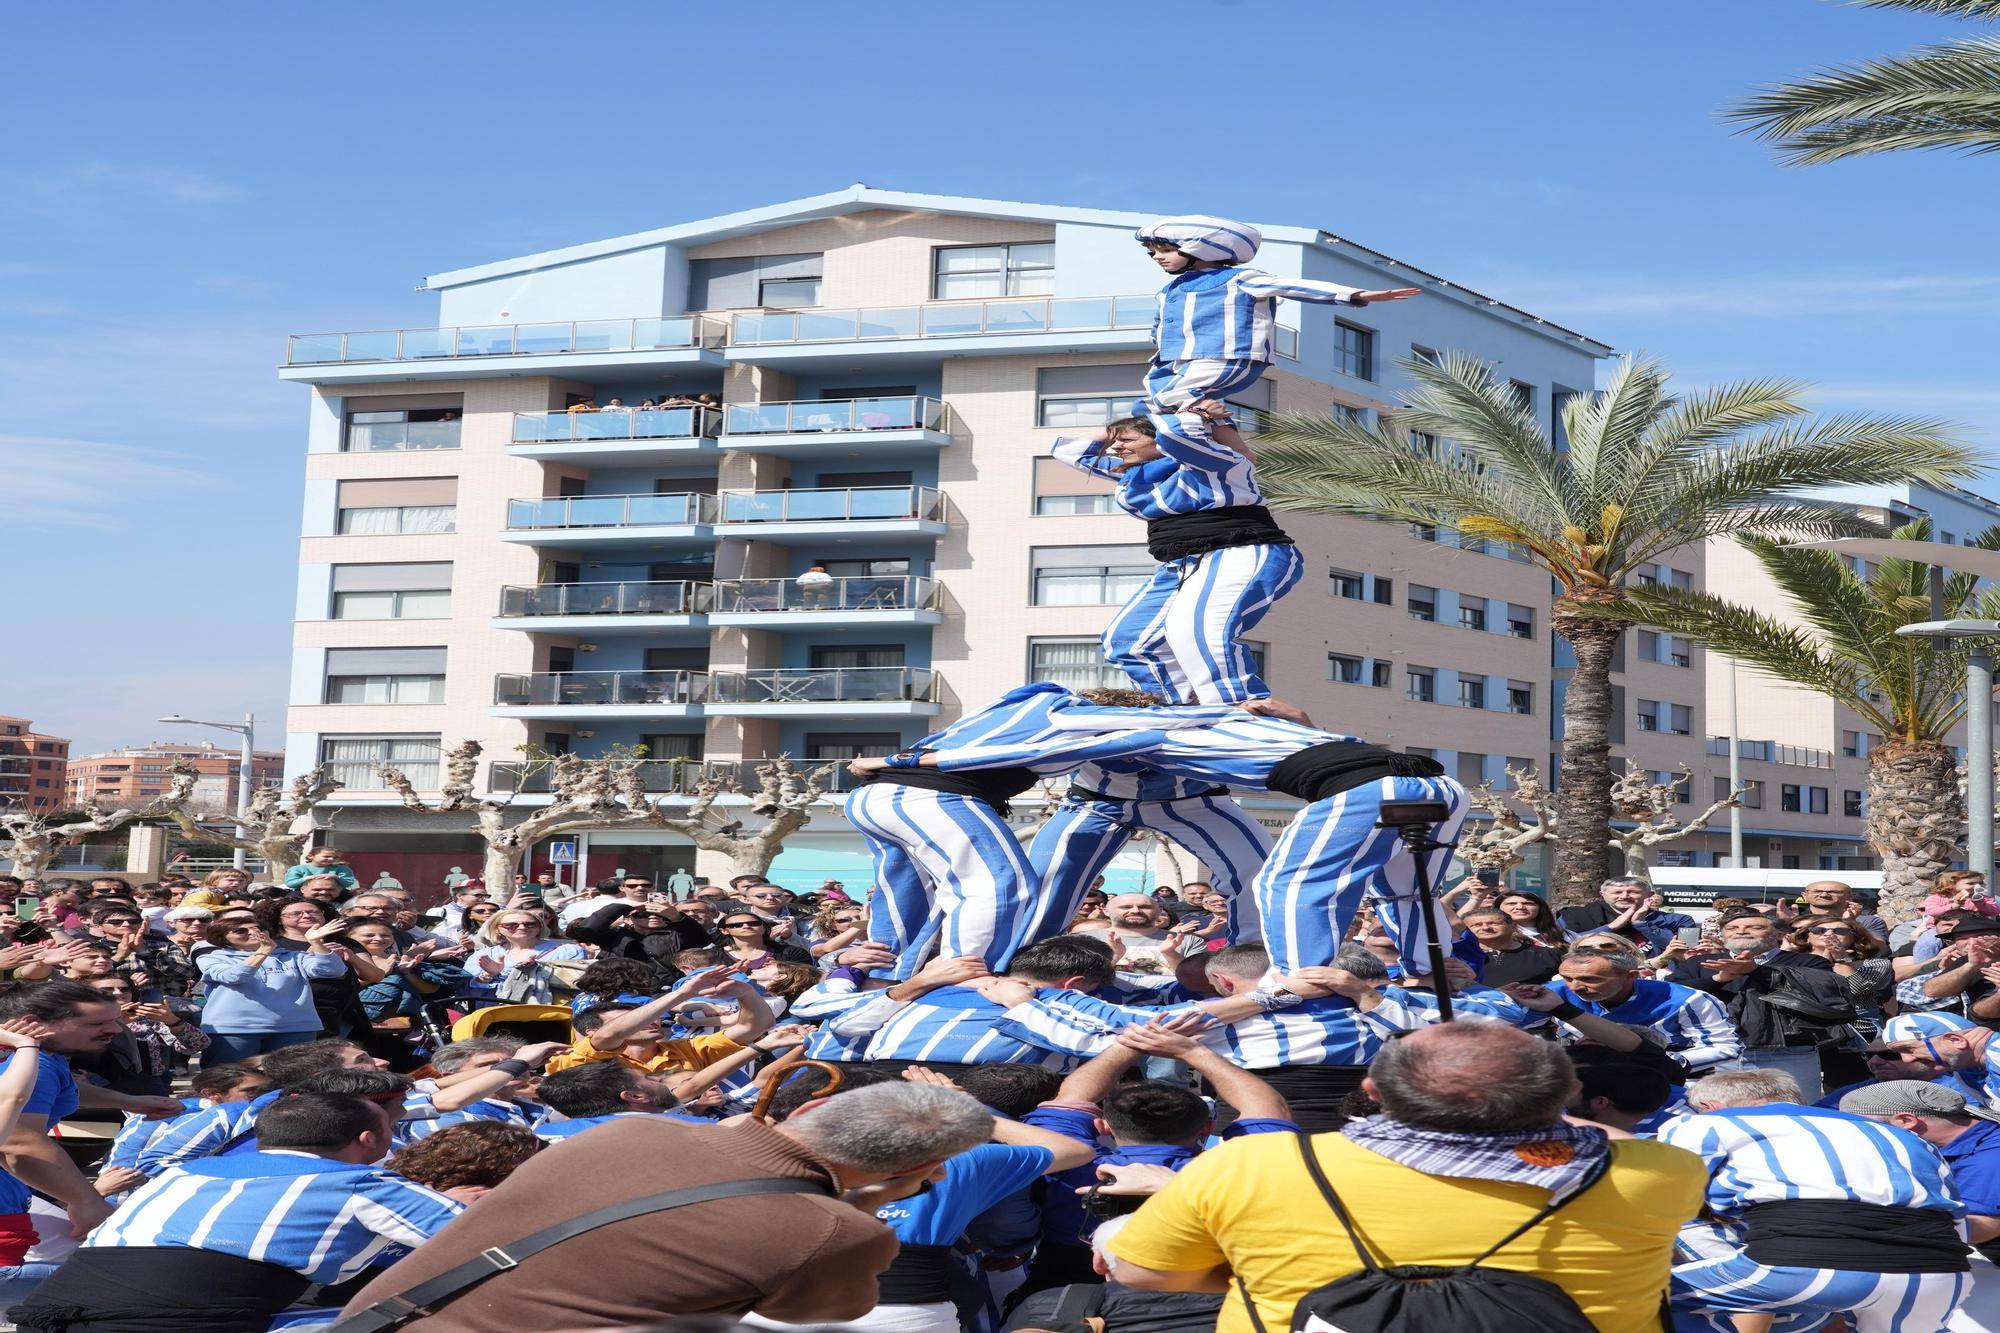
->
[1724,0,2000,166]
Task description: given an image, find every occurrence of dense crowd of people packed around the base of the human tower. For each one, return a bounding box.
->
[0,851,2000,1333]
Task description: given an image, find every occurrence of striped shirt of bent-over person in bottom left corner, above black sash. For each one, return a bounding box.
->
[84,1151,460,1283]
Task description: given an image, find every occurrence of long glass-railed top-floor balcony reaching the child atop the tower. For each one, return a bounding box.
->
[728,296,1158,364]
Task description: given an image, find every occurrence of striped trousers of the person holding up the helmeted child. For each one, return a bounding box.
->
[1104,546,1306,705]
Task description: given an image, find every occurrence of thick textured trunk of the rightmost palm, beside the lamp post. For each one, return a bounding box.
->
[1866,741,1966,921]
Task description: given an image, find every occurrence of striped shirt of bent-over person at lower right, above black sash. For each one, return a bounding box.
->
[1656,1103,1966,1219]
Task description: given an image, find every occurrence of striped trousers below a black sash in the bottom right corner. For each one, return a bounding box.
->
[1668,1253,1968,1333]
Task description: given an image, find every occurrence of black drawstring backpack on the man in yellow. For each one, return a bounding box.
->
[1236,1135,1610,1333]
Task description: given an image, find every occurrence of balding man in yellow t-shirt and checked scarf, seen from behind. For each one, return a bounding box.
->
[1108,1019,1708,1333]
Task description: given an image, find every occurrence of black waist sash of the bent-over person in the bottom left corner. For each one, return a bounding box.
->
[8,1247,312,1333]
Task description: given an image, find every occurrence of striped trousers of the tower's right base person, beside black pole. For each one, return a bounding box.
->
[1250,777,1466,973]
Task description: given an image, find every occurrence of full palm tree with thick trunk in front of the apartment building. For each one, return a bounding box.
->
[1258,352,1978,903]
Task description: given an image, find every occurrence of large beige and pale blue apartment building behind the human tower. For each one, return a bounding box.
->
[280,186,1888,885]
